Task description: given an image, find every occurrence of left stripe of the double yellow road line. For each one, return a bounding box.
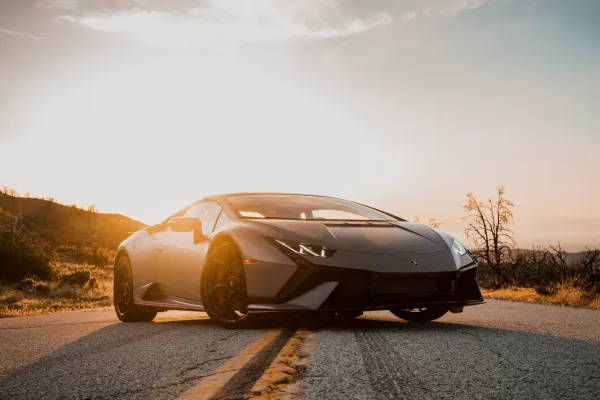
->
[179,329,282,400]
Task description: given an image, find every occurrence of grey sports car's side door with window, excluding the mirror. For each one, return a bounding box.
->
[165,201,221,301]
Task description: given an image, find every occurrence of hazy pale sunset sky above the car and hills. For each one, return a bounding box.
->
[0,0,600,250]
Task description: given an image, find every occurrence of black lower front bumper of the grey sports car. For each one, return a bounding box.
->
[248,257,483,311]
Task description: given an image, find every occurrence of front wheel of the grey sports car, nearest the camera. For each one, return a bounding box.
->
[200,240,253,328]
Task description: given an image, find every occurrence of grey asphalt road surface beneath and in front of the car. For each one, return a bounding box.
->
[0,300,600,399]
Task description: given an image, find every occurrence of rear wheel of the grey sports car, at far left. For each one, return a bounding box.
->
[113,255,157,322]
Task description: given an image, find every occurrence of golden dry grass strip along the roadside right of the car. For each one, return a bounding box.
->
[482,285,600,310]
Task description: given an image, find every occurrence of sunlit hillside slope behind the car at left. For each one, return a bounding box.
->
[0,192,147,249]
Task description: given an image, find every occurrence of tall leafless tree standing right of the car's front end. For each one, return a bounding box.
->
[463,186,516,281]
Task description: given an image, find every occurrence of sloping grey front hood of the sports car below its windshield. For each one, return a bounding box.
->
[252,220,448,253]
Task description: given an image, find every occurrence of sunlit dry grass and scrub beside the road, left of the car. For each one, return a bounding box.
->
[0,264,112,318]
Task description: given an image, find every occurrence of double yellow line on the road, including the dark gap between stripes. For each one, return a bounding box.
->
[179,329,317,400]
